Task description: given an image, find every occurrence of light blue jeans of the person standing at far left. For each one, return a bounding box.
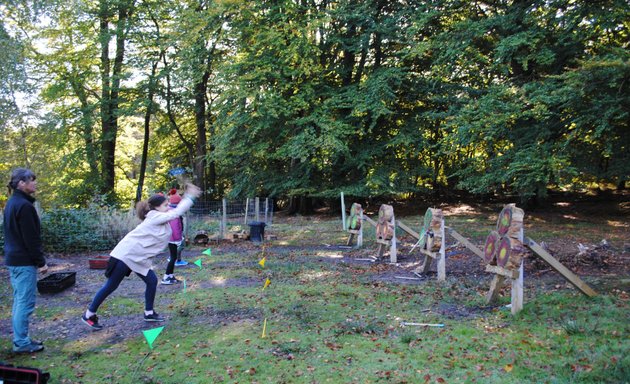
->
[8,266,37,347]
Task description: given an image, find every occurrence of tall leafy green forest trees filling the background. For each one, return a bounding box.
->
[0,0,630,212]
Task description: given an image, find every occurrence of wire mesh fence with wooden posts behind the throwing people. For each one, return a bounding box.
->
[0,198,273,253]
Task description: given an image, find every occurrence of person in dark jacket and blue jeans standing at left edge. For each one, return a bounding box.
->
[4,168,48,353]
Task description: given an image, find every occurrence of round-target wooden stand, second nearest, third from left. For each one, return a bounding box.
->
[412,208,446,281]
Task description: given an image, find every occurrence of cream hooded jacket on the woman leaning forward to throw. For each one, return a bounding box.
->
[110,195,193,276]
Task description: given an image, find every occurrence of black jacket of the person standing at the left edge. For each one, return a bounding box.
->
[4,189,46,268]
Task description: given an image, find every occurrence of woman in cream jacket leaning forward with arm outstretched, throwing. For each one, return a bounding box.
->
[81,183,201,331]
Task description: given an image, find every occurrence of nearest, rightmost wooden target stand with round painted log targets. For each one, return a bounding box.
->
[483,204,528,314]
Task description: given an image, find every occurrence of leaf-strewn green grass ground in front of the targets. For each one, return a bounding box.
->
[0,212,630,383]
